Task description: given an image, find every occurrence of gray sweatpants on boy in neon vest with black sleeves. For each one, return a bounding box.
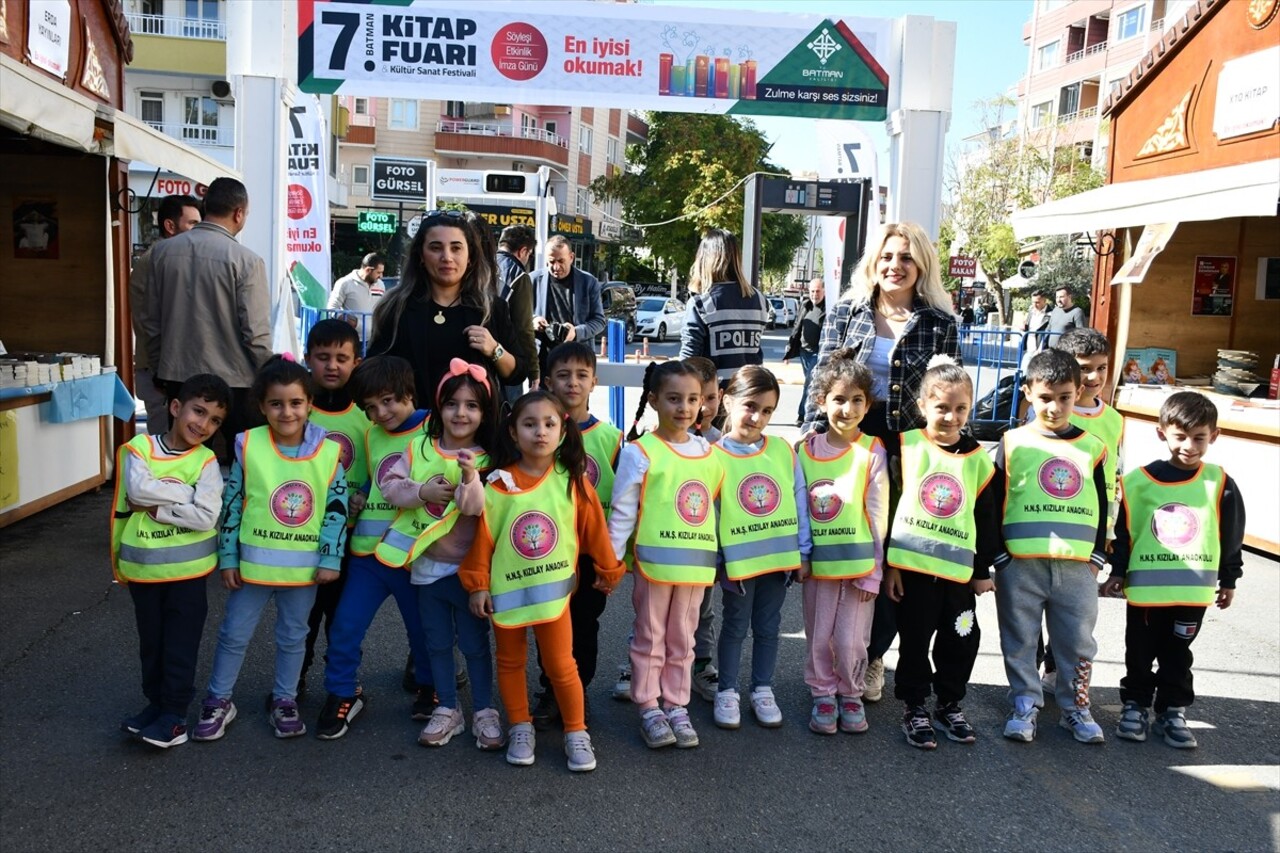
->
[996,557,1098,711]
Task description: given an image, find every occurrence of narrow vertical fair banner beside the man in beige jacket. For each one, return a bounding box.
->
[284,97,333,309]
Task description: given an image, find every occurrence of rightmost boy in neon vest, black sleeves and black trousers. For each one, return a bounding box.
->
[1102,391,1244,749]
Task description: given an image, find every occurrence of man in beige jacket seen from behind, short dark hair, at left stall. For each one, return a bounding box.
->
[143,178,271,462]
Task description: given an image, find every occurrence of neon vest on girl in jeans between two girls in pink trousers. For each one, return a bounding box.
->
[716,435,800,580]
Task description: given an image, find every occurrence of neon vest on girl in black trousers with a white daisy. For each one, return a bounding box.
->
[886,429,993,584]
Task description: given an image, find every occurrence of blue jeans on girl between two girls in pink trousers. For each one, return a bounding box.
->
[717,571,787,690]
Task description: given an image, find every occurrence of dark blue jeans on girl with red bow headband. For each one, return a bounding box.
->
[417,574,493,711]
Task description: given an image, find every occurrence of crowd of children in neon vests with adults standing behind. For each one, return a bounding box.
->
[111,197,1244,771]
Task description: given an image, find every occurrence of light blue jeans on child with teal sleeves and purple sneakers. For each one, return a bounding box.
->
[209,583,316,699]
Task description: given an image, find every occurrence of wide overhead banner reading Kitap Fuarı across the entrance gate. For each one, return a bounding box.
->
[298,0,891,122]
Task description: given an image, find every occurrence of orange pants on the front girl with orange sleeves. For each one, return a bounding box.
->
[493,607,586,733]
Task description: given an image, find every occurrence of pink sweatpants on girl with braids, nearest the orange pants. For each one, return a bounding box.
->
[631,571,705,711]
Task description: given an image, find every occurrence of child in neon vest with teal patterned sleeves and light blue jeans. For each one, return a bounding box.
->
[195,356,347,740]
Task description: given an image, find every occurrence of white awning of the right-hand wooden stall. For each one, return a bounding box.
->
[1012,159,1280,240]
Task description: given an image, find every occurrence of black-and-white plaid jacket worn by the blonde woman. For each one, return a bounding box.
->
[804,297,960,433]
